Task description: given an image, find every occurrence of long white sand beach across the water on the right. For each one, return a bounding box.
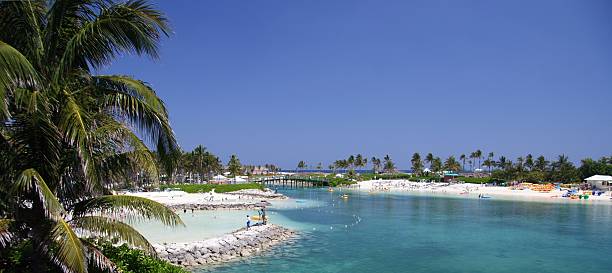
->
[352,180,612,204]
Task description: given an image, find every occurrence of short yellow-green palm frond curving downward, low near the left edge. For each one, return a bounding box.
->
[13,169,65,219]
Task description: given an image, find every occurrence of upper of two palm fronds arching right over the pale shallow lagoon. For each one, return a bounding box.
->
[73,195,184,226]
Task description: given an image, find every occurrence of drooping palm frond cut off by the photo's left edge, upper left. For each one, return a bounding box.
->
[0,41,37,119]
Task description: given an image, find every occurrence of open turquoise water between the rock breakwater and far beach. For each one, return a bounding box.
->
[195,190,612,273]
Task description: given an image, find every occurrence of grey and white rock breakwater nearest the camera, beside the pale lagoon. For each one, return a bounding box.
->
[153,225,296,267]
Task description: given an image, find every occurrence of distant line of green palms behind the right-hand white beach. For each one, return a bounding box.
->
[297,150,612,183]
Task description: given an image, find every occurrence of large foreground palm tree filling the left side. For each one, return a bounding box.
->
[0,1,182,273]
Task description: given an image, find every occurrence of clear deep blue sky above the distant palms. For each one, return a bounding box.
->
[101,0,612,168]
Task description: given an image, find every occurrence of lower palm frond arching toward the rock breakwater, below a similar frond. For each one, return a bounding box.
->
[70,216,155,255]
